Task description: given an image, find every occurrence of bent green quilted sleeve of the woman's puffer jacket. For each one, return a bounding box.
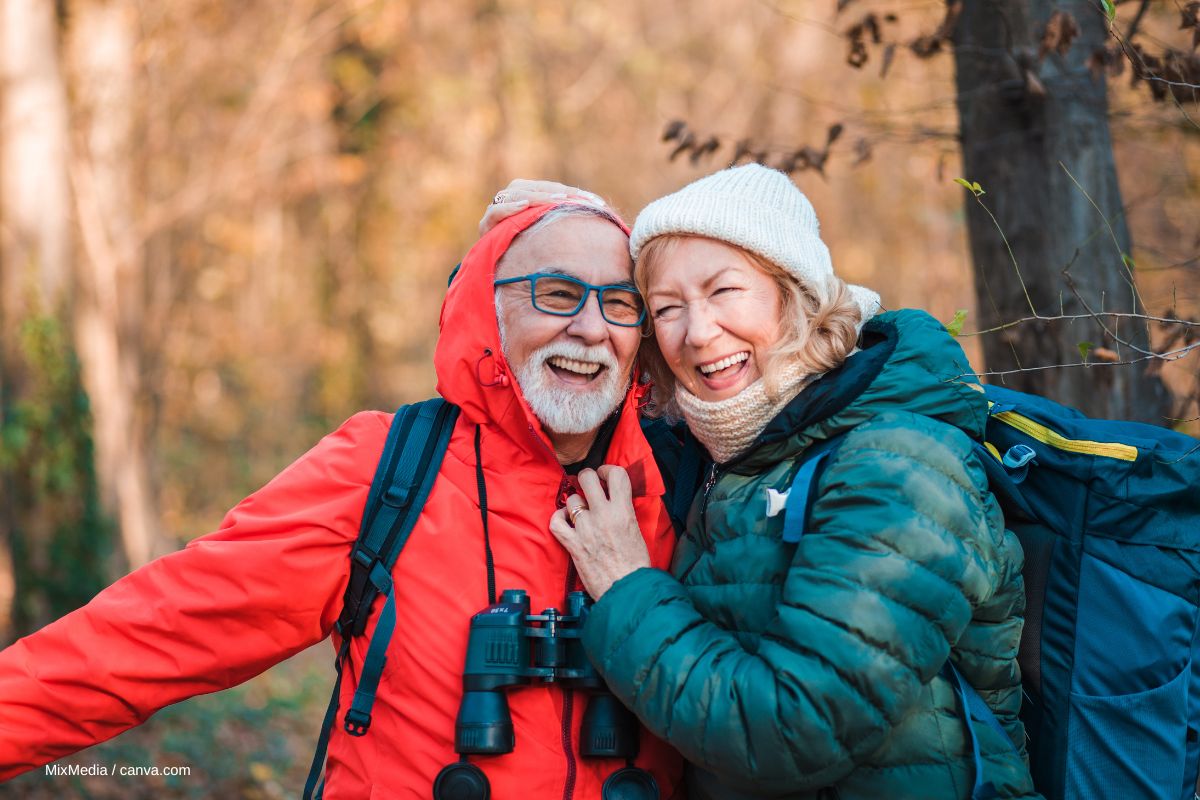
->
[584,414,1000,794]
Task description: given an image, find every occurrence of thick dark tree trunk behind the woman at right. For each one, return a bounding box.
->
[950,0,1166,425]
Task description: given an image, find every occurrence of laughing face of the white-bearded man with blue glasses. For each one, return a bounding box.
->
[496,212,641,434]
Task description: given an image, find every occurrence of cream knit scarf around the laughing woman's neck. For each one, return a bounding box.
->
[676,362,820,464]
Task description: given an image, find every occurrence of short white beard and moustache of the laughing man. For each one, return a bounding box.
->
[500,323,629,434]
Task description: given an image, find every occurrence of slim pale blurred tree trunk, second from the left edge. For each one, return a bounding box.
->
[70,0,160,569]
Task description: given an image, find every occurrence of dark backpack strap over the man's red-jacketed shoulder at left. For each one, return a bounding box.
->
[304,397,458,800]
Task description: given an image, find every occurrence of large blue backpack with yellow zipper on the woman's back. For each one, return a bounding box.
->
[784,386,1200,800]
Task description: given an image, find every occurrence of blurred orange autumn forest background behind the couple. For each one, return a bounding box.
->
[0,0,1200,798]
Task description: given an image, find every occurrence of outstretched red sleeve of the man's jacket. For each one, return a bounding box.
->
[0,413,386,780]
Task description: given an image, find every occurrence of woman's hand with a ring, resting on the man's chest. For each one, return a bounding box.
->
[550,464,650,600]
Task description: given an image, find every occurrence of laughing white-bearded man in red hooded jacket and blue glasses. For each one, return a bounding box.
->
[0,205,682,800]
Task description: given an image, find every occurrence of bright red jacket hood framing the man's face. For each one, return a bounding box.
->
[433,205,664,494]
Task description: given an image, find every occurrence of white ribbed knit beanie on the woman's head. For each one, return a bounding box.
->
[629,164,880,321]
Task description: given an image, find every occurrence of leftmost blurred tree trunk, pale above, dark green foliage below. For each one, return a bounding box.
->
[0,0,107,642]
